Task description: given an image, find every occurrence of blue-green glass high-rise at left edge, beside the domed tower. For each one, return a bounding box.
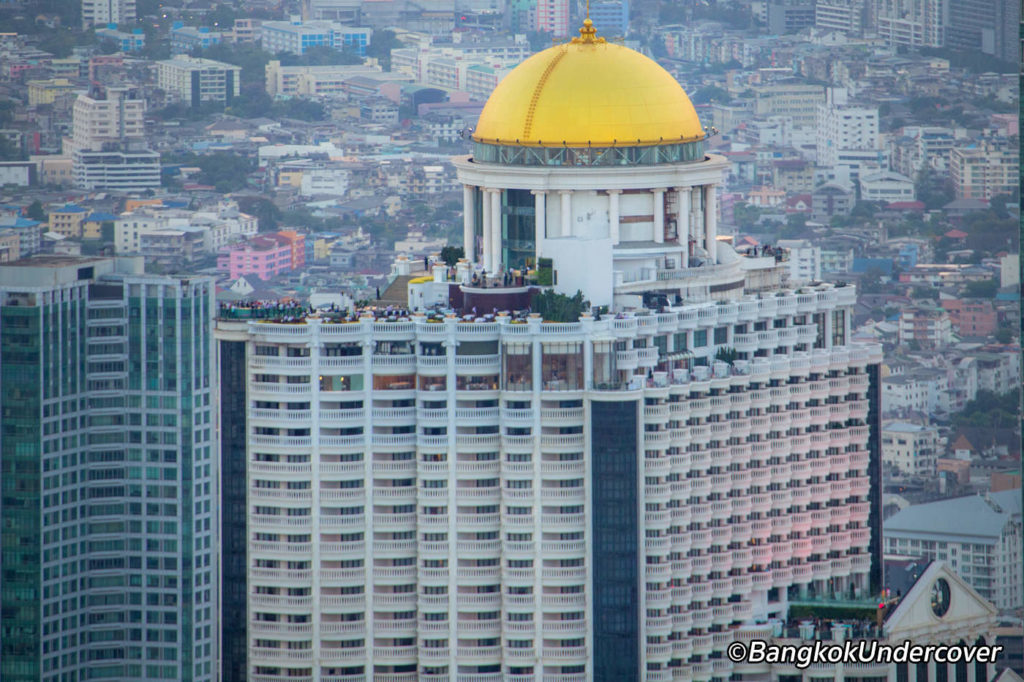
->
[0,256,219,682]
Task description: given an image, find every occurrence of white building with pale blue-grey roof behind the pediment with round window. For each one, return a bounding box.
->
[883,489,1024,610]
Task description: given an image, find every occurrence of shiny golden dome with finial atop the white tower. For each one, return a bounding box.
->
[473,18,705,147]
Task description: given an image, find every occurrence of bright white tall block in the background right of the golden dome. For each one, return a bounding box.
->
[817,88,879,168]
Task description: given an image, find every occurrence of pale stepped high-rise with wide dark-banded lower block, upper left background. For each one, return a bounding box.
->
[65,88,160,190]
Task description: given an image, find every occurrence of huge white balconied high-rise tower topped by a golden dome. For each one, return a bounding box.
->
[217,22,881,682]
